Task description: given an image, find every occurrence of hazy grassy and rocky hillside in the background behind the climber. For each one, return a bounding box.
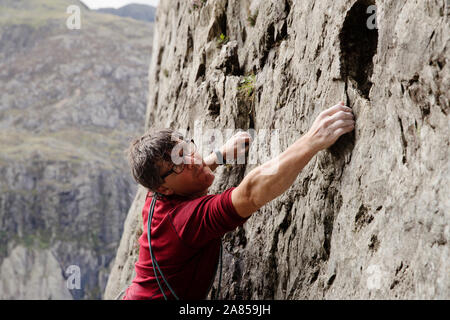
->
[0,0,153,299]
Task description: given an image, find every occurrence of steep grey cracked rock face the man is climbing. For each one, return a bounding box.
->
[105,0,450,299]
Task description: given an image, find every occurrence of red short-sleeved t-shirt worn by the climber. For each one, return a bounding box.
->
[123,188,247,300]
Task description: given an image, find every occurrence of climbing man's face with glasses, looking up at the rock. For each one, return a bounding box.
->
[158,140,214,196]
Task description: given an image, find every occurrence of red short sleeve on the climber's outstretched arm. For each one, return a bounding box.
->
[171,188,248,248]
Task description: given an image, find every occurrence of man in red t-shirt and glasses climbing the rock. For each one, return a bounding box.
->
[123,102,355,300]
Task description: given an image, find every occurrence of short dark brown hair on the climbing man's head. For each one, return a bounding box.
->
[128,129,183,191]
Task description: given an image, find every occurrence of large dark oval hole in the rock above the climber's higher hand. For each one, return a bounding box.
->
[339,0,378,99]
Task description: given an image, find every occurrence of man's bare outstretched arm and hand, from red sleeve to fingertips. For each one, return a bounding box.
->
[231,103,355,218]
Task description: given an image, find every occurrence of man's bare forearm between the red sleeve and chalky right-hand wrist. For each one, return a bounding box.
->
[232,136,317,217]
